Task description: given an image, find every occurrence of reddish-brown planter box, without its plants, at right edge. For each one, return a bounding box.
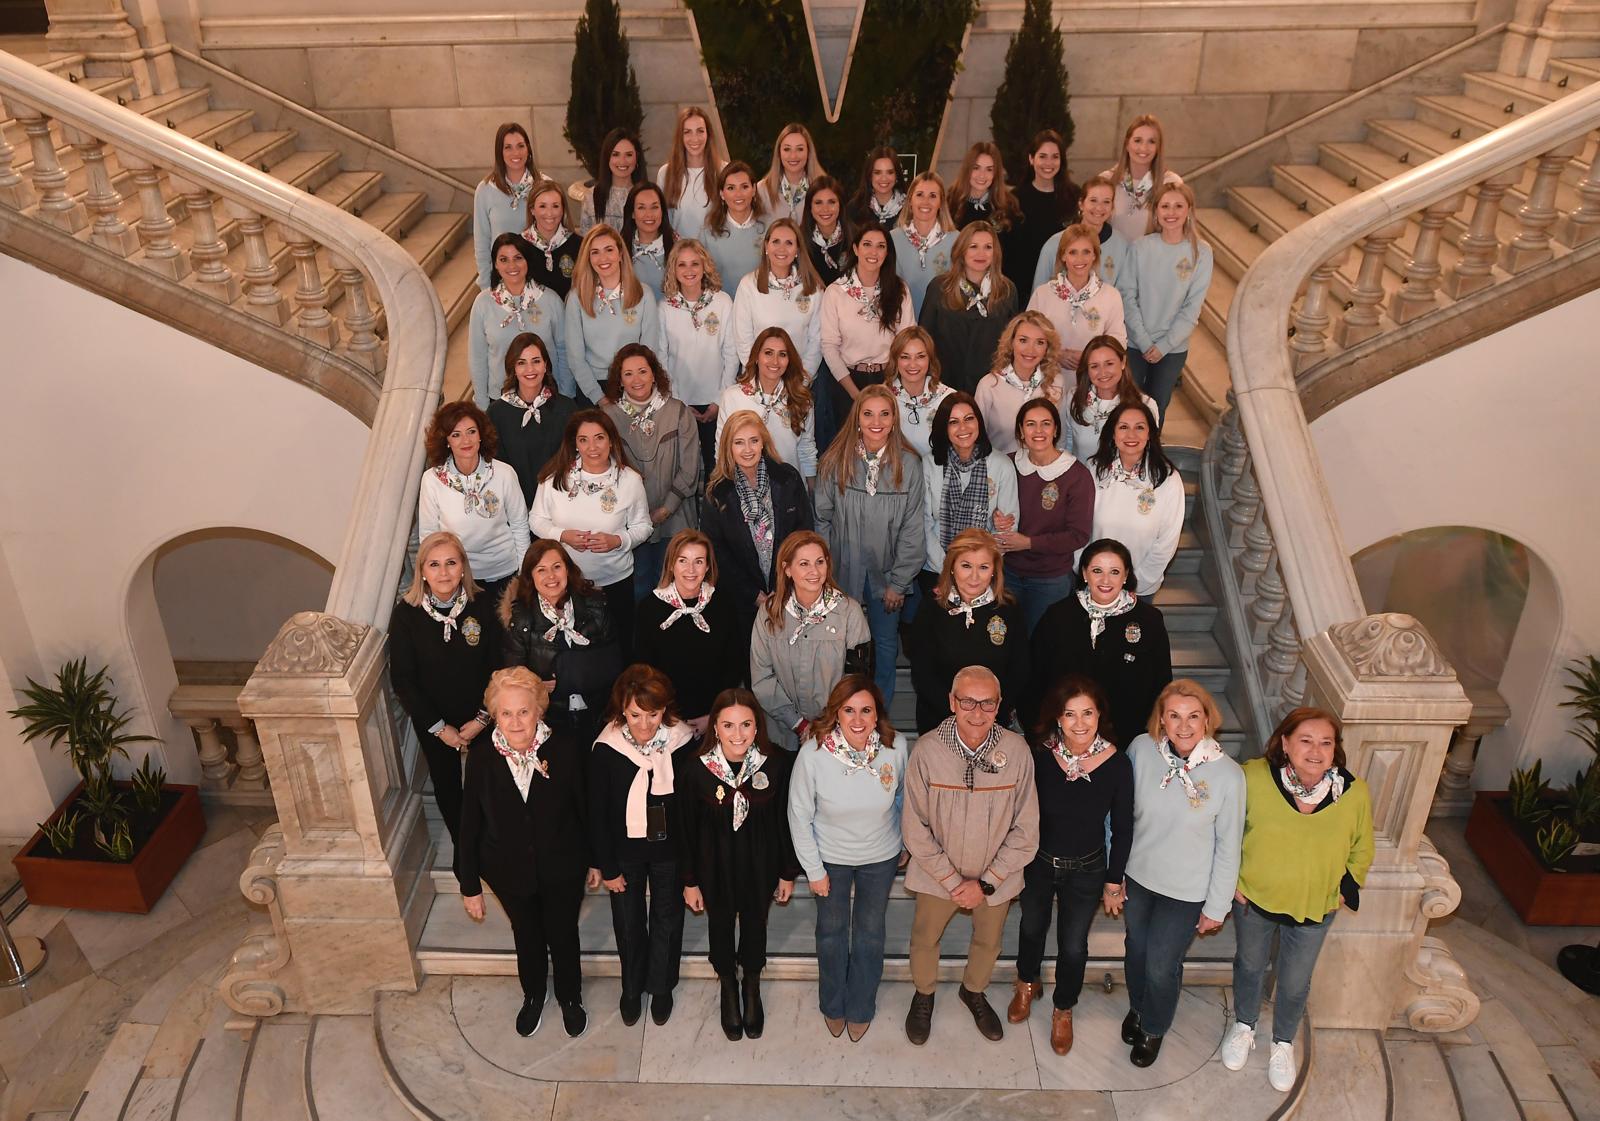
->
[1467,790,1600,926]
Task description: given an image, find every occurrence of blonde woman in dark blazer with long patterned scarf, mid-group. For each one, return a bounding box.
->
[701,409,811,664]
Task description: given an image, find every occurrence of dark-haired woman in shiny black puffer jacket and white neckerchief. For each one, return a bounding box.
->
[499,537,622,745]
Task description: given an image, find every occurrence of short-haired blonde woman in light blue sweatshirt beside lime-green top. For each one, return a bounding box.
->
[1122,678,1245,1067]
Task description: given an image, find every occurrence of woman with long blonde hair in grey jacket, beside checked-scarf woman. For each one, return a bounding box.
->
[814,385,928,707]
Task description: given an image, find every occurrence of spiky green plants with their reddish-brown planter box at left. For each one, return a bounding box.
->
[11,659,205,915]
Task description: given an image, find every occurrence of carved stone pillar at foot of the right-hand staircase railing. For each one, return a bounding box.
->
[1306,614,1477,1031]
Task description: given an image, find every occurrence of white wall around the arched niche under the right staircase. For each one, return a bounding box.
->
[1312,291,1600,788]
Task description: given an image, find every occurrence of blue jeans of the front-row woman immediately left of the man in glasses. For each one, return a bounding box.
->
[816,854,899,1023]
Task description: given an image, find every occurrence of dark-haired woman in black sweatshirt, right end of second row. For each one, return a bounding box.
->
[1026,537,1173,750]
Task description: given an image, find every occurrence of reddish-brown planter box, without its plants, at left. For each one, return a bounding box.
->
[13,784,205,915]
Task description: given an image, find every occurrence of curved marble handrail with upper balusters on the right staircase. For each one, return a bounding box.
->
[1227,85,1600,640]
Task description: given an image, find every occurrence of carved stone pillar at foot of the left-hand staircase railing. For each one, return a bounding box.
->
[221,611,434,1015]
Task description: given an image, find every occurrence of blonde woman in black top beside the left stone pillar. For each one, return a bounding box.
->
[389,531,501,859]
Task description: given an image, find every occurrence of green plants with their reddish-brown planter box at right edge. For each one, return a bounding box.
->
[1467,654,1600,926]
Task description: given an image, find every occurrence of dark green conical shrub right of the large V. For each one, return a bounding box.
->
[989,0,1074,182]
